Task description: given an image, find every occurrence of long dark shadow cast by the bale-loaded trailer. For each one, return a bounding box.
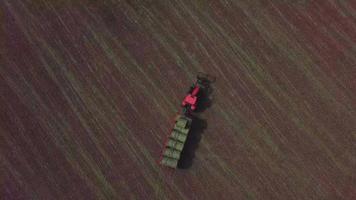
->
[178,116,208,169]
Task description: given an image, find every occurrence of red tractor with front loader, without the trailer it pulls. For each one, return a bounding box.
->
[182,73,212,114]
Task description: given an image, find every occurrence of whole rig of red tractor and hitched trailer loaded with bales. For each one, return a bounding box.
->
[160,73,212,168]
